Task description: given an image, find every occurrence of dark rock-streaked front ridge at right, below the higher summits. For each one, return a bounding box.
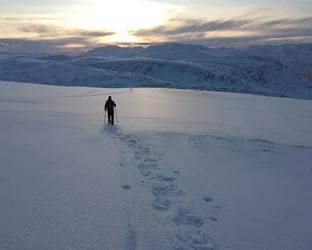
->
[86,57,312,96]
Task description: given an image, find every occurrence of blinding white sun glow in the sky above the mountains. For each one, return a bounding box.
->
[64,0,170,42]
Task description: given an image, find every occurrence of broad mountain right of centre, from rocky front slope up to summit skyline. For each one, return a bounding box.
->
[80,43,312,97]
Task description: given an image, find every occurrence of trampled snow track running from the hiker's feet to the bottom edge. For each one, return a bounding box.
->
[104,125,218,250]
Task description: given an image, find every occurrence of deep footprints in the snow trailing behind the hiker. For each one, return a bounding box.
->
[111,132,217,250]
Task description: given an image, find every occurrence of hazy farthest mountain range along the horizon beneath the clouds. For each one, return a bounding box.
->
[81,43,312,80]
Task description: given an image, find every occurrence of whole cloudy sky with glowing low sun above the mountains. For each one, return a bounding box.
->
[0,0,312,50]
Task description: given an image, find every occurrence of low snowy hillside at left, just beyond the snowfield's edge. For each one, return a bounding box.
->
[0,57,171,87]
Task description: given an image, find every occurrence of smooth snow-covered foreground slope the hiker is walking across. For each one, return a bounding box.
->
[0,82,312,250]
